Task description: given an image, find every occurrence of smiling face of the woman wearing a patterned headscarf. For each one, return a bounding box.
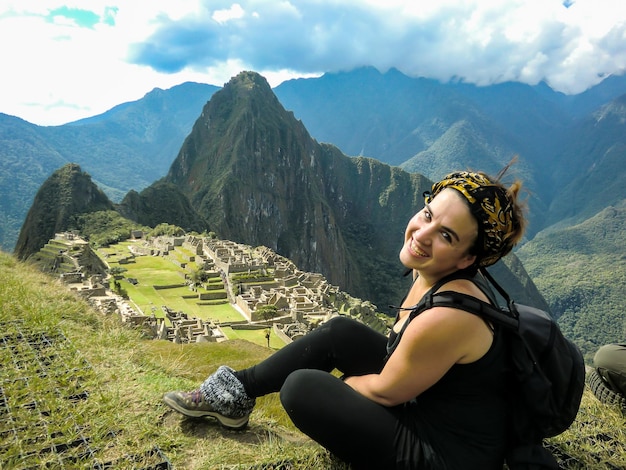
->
[400,188,478,279]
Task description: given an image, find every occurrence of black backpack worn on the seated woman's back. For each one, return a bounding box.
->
[411,268,585,470]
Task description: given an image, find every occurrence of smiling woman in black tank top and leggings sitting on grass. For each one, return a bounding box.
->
[164,168,525,470]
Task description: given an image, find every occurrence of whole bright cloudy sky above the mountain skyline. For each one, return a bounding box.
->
[0,0,626,126]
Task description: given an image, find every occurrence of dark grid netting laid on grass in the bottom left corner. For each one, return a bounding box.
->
[0,320,172,470]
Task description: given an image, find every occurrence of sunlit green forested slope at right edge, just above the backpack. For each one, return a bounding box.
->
[517,200,626,360]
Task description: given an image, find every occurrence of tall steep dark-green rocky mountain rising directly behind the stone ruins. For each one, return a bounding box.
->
[165,72,541,310]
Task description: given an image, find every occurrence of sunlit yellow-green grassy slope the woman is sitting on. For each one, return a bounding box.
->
[0,248,626,469]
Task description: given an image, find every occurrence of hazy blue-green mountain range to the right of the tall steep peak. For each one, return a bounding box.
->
[276,69,626,348]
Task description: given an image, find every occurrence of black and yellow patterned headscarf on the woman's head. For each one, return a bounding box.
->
[424,171,519,267]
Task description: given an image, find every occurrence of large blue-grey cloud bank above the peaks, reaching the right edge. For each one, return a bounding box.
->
[129,0,626,93]
